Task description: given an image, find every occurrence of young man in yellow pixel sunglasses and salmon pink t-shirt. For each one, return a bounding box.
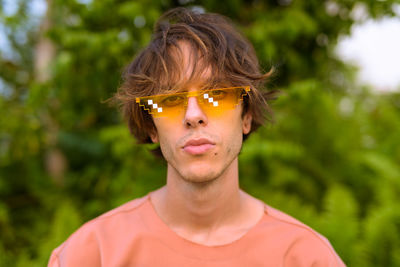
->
[49,8,344,267]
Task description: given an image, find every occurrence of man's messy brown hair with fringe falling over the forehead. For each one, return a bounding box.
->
[114,7,275,149]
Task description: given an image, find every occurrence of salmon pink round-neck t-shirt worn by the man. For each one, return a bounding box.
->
[48,194,345,267]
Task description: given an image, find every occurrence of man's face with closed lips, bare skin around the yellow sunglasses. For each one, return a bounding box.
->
[151,43,252,182]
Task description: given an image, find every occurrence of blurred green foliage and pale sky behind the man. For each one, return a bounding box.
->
[0,0,400,267]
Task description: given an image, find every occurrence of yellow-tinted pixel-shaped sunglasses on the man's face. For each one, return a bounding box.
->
[136,86,250,118]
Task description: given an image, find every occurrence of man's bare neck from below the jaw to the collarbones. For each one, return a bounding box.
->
[159,159,244,232]
